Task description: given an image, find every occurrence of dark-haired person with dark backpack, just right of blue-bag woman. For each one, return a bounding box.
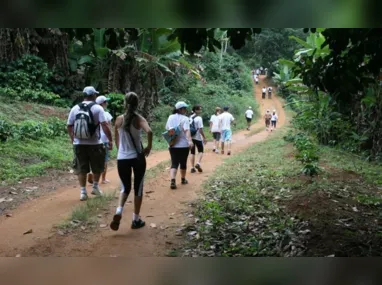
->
[190,105,207,173]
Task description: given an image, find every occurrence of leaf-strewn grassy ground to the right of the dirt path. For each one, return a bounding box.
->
[181,129,382,256]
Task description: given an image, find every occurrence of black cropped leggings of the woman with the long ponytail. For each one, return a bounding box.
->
[117,158,146,197]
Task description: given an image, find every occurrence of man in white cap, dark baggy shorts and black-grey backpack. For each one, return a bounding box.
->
[67,86,113,201]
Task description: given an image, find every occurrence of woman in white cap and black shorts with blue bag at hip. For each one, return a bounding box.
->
[166,102,194,189]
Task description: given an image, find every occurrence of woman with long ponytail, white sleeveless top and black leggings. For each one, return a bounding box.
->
[110,92,153,231]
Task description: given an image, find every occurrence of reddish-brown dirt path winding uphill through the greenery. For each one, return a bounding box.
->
[0,76,285,257]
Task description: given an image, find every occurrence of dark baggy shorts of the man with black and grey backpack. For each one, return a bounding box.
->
[73,144,106,175]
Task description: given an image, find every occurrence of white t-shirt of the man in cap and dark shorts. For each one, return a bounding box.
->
[67,101,106,145]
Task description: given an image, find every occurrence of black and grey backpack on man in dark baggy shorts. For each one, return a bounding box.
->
[74,102,99,139]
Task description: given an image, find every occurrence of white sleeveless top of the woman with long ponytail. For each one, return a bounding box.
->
[117,115,142,160]
